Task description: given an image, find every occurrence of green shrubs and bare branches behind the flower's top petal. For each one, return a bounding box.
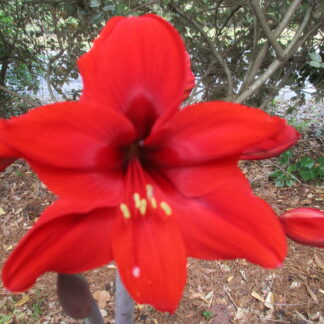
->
[0,0,324,117]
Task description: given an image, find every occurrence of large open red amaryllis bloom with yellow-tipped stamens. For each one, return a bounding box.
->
[0,15,298,312]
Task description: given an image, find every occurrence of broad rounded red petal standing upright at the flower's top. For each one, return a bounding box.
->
[79,15,188,136]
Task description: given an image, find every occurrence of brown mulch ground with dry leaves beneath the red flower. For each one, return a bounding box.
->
[0,133,324,324]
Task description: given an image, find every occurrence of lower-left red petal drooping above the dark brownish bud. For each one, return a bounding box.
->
[2,201,114,291]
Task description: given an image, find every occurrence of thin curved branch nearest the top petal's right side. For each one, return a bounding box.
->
[169,2,233,100]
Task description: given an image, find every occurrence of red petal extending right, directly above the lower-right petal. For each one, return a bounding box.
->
[144,102,285,166]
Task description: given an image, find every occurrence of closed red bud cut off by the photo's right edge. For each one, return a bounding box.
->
[280,208,324,247]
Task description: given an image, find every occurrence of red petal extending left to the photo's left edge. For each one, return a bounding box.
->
[1,102,135,200]
